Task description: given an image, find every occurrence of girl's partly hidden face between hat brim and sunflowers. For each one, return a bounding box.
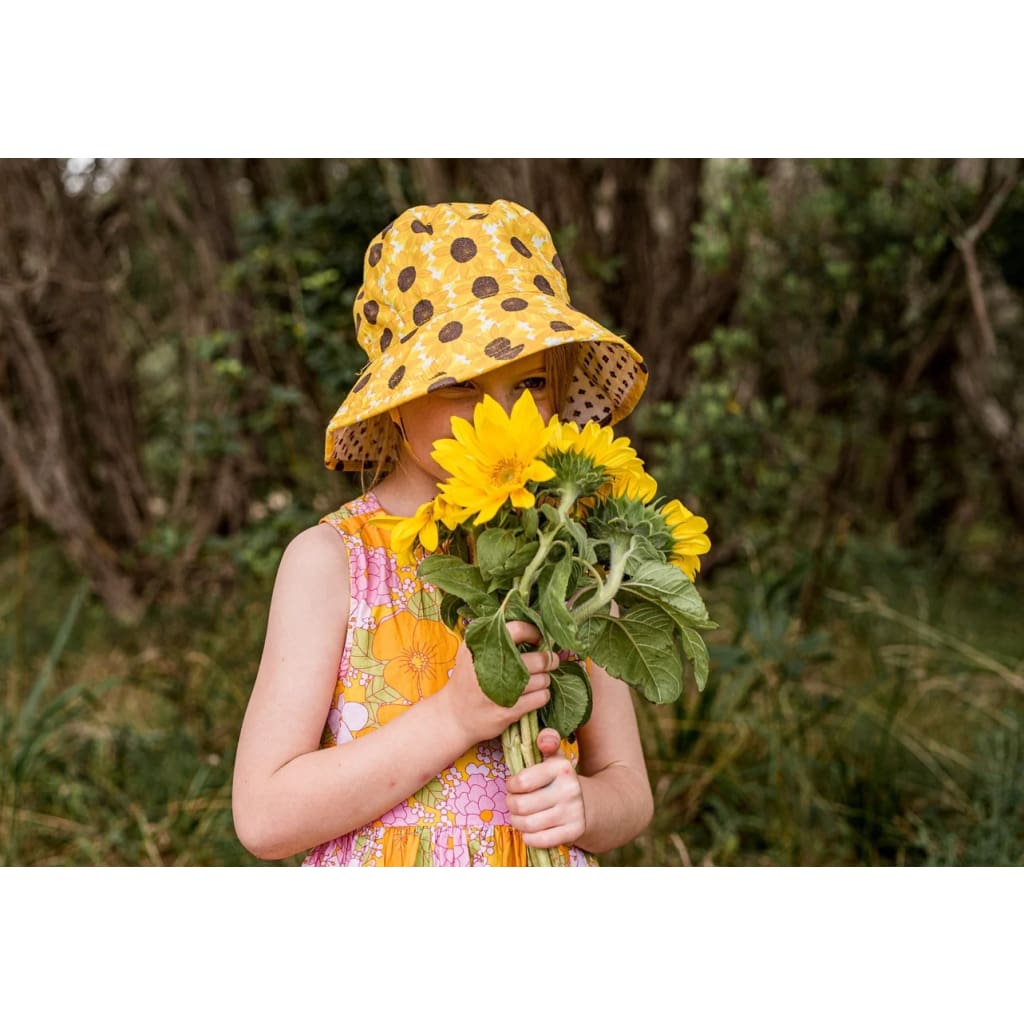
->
[399,352,555,480]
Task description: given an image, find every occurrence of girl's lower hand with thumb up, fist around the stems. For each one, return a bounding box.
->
[506,729,587,849]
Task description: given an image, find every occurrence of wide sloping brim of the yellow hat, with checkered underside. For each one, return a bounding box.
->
[324,292,647,469]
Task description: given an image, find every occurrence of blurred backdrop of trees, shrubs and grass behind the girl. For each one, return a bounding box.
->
[0,159,1024,865]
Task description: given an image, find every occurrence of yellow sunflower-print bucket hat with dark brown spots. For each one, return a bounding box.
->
[324,200,647,469]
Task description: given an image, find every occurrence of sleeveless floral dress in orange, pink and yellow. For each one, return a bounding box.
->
[303,492,596,867]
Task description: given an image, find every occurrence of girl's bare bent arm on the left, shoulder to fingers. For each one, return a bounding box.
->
[231,525,550,859]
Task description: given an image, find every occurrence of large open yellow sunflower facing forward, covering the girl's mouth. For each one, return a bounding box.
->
[433,391,554,524]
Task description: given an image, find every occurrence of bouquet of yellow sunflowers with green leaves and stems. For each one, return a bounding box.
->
[392,391,717,863]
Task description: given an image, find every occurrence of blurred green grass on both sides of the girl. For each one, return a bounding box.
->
[0,541,1024,865]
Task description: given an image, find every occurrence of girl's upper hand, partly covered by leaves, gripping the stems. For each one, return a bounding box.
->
[434,622,558,749]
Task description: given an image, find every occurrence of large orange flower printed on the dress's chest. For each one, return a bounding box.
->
[373,610,459,700]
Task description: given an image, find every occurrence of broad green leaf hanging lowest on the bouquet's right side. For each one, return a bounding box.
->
[580,615,683,703]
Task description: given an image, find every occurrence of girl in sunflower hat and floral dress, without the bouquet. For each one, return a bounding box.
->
[232,200,652,865]
